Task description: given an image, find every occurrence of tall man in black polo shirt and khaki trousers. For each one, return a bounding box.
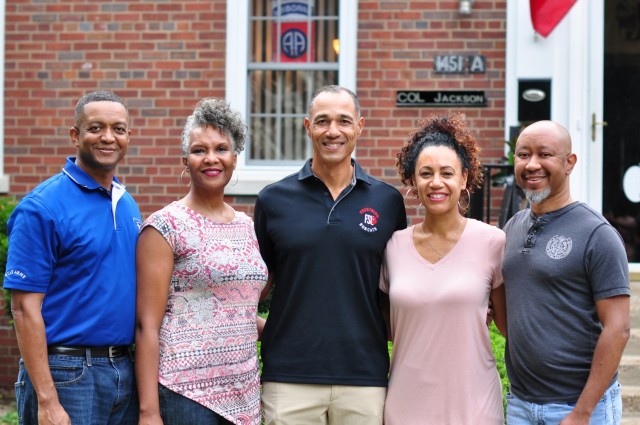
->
[255,86,406,425]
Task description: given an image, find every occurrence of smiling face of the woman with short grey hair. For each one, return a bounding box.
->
[182,126,238,191]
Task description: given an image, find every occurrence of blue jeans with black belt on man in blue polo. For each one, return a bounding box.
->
[16,354,139,425]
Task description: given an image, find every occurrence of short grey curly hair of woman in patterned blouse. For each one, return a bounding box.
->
[181,97,247,156]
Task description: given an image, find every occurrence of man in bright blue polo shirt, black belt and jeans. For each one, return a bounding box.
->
[4,91,140,424]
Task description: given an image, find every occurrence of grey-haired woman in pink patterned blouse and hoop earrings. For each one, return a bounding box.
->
[136,99,267,425]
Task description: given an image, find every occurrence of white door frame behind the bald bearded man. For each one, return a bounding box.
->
[504,0,640,270]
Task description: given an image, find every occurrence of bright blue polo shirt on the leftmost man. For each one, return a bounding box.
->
[4,158,141,346]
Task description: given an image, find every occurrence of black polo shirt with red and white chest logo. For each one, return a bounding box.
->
[254,160,407,386]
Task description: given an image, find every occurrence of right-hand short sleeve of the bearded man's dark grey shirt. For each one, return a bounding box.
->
[585,223,631,301]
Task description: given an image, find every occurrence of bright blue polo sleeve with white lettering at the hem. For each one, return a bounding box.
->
[3,198,61,293]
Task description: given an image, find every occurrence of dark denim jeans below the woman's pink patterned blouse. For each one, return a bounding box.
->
[158,384,232,425]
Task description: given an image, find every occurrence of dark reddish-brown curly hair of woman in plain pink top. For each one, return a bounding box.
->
[396,113,484,192]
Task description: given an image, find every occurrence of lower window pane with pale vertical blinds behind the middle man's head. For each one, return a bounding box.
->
[247,70,338,165]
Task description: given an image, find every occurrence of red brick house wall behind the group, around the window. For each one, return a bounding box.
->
[0,0,506,388]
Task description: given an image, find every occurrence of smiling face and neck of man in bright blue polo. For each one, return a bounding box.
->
[69,101,131,188]
